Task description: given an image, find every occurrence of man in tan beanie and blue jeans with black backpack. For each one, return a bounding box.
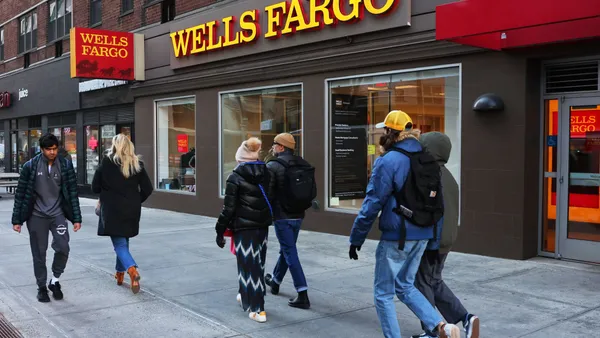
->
[265,133,317,309]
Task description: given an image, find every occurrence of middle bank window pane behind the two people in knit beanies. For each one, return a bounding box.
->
[220,85,302,195]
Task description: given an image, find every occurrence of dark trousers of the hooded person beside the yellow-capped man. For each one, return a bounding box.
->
[415,250,468,329]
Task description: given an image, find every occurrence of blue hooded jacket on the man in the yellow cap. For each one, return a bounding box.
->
[350,138,433,246]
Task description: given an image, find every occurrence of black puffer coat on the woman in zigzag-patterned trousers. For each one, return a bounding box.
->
[216,162,273,234]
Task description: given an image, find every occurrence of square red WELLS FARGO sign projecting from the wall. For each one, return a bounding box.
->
[71,27,144,80]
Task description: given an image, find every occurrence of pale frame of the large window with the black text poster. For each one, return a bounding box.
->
[321,63,463,215]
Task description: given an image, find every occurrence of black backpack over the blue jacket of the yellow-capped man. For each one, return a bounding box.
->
[390,148,444,248]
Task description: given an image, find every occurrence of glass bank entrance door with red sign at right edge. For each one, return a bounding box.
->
[557,98,600,262]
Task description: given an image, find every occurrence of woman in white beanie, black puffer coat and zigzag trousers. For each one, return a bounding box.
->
[216,137,273,323]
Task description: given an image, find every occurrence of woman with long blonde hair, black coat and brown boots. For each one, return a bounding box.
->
[92,134,153,293]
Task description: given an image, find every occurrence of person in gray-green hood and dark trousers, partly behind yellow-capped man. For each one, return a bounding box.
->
[412,132,479,338]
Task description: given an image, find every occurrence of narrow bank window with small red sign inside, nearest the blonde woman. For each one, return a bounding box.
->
[156,97,196,193]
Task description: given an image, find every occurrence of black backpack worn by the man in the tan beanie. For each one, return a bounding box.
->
[272,156,317,213]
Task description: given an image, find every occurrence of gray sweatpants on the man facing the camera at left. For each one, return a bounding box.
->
[27,216,69,286]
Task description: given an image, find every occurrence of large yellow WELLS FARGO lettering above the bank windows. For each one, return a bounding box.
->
[171,0,400,57]
